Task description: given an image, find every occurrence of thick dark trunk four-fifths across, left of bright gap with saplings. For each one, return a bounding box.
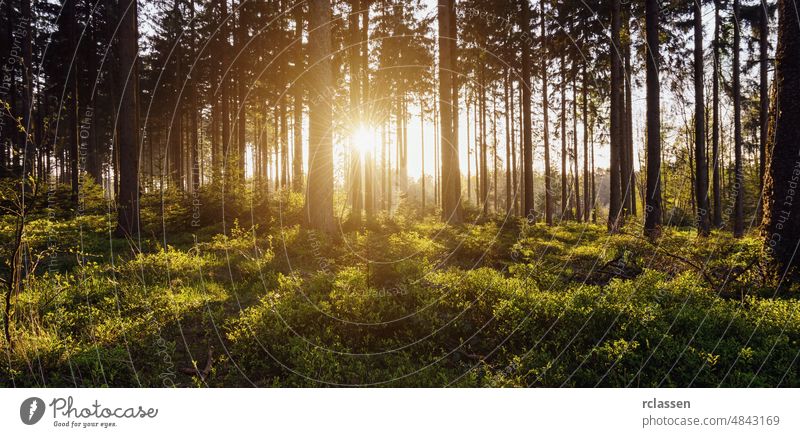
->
[644,0,661,238]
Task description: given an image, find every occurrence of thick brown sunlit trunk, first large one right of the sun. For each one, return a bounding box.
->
[437,0,463,224]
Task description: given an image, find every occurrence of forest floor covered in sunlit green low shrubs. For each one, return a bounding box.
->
[0,183,800,387]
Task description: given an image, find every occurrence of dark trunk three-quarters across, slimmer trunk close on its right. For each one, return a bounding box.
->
[608,0,624,233]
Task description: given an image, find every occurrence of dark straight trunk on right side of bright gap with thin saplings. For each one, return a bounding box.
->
[694,2,710,236]
